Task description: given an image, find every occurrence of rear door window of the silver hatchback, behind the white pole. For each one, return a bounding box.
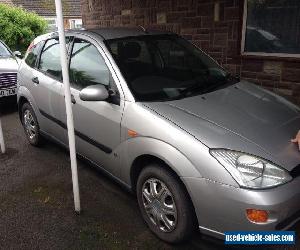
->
[39,37,70,80]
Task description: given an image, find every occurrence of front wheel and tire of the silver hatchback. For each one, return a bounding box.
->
[136,164,197,243]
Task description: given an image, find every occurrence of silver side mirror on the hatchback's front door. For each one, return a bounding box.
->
[79,84,109,101]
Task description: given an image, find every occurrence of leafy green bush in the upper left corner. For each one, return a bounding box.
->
[0,4,47,52]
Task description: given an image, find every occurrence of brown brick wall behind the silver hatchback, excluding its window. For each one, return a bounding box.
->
[81,0,300,105]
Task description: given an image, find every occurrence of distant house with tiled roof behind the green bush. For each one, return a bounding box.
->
[0,0,82,31]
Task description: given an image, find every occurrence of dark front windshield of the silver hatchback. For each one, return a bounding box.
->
[105,35,236,102]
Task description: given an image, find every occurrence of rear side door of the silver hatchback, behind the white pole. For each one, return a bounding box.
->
[32,38,70,142]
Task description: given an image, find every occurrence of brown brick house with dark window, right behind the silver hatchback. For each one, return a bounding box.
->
[81,0,300,105]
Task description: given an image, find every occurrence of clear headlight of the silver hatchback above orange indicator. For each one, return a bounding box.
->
[210,149,292,189]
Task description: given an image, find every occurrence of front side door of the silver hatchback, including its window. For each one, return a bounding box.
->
[64,38,124,178]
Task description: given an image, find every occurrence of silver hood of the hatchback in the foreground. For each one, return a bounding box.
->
[143,81,300,170]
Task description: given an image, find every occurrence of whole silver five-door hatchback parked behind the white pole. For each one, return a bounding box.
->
[18,28,300,243]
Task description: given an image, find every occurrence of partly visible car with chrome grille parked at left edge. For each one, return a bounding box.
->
[0,40,21,101]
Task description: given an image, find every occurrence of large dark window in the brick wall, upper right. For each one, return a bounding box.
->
[242,0,300,57]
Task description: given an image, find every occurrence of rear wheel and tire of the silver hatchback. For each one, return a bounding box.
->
[21,103,43,147]
